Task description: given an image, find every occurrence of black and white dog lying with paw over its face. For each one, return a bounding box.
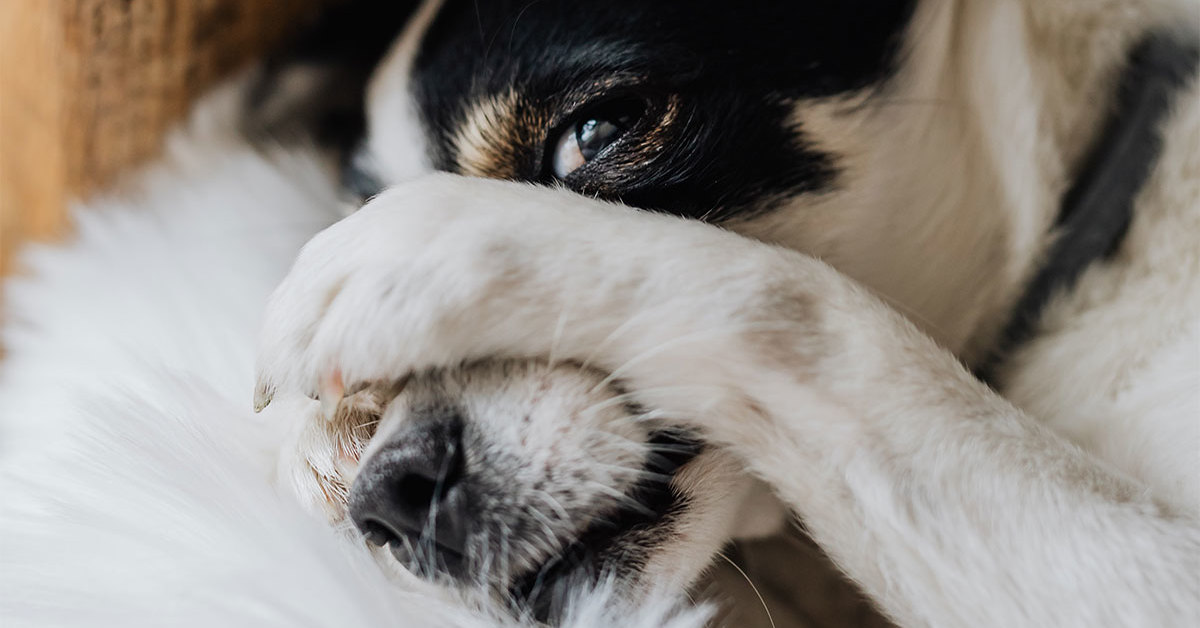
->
[2,0,1200,627]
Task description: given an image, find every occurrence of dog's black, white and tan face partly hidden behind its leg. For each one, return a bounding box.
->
[265,0,986,615]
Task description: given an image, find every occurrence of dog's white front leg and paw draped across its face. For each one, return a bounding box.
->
[259,175,1200,627]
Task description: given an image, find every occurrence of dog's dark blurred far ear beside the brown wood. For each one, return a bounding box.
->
[241,0,418,155]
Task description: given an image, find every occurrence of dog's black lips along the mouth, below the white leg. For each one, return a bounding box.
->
[509,430,703,622]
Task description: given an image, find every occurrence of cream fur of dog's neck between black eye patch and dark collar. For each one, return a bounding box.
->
[748,0,1195,363]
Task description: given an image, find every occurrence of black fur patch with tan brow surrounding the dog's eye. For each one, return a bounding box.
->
[369,0,913,216]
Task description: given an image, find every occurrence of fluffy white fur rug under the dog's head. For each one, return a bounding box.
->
[0,91,708,628]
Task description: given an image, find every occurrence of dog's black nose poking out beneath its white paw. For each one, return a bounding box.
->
[349,415,470,578]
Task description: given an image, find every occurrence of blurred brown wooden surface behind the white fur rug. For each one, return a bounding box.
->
[0,0,329,274]
